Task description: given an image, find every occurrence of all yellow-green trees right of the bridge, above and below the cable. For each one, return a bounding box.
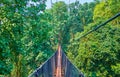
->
[68,1,120,77]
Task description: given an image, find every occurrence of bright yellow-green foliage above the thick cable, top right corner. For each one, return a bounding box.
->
[93,0,120,24]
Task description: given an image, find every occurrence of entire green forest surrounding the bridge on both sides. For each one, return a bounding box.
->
[0,0,120,77]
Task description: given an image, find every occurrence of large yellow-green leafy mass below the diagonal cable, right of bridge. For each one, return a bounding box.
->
[75,25,120,77]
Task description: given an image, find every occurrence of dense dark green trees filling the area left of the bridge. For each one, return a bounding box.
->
[0,0,51,77]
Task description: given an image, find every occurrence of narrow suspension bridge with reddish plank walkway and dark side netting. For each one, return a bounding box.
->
[28,46,84,77]
